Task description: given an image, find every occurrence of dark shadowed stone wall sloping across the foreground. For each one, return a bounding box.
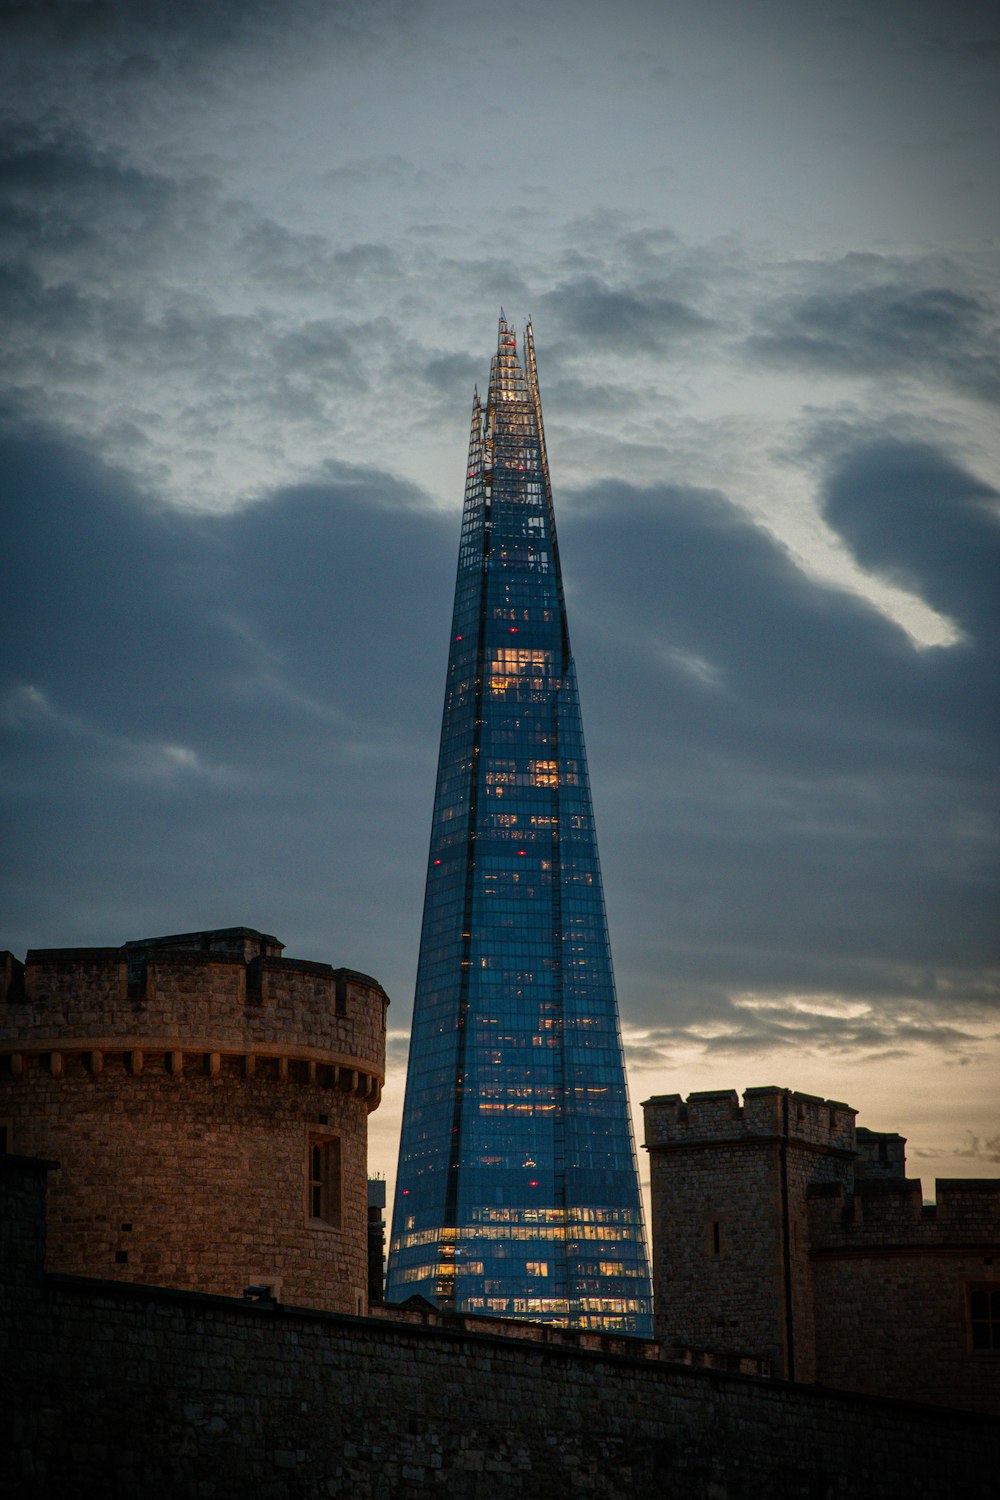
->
[0,1158,1000,1500]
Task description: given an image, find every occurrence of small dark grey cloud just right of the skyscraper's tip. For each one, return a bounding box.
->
[543,276,712,353]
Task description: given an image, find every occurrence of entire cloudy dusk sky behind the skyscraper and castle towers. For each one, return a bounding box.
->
[0,0,1000,1224]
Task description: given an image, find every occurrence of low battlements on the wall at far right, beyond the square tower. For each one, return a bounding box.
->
[807,1178,1000,1254]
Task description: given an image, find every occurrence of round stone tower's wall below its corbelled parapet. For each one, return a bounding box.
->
[0,1053,367,1313]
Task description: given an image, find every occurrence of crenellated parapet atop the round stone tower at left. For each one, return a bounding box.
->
[0,927,388,1103]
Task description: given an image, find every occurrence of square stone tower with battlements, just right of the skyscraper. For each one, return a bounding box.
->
[643,1088,855,1380]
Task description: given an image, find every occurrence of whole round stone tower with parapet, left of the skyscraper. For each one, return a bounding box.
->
[0,927,388,1314]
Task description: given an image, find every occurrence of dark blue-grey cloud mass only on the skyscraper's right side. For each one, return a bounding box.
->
[562,438,999,1047]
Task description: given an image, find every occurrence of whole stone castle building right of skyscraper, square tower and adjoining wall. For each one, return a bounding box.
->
[643,1088,1000,1412]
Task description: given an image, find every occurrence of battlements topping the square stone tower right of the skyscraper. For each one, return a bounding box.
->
[643,1085,858,1154]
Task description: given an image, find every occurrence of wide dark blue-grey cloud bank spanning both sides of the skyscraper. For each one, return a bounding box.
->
[0,405,997,1062]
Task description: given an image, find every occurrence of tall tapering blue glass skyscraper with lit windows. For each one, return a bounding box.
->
[387,314,652,1337]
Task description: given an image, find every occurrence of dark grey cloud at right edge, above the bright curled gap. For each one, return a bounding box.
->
[747,257,1000,401]
